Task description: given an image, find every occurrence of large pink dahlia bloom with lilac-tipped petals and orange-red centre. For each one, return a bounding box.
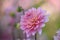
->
[20,8,48,37]
